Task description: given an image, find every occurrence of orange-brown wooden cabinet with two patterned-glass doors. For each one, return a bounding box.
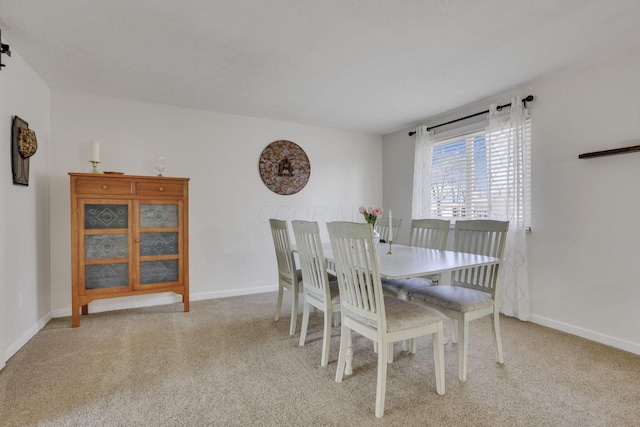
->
[69,172,189,327]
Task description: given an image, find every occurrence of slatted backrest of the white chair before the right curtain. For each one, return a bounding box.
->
[451,220,509,295]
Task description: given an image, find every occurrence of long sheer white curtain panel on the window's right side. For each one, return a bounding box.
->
[485,98,531,321]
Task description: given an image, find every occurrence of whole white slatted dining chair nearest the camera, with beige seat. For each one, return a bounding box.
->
[327,222,445,418]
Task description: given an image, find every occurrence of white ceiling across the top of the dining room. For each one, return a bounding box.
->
[0,0,640,135]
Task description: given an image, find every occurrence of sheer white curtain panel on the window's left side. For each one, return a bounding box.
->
[411,126,433,218]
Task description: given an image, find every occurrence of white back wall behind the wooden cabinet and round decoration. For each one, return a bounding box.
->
[51,90,382,317]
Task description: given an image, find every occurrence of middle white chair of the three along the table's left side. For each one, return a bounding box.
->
[291,221,340,366]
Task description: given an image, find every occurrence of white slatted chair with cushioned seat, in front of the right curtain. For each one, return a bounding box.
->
[409,220,509,381]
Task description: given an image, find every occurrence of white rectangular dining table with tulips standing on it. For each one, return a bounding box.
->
[293,243,502,375]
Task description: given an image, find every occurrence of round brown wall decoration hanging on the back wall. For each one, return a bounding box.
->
[259,139,311,196]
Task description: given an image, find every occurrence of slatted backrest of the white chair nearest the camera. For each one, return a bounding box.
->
[327,222,386,331]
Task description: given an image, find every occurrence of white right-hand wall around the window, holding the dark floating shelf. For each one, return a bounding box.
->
[383,46,640,354]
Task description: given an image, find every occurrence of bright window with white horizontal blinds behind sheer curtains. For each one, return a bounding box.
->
[416,113,531,227]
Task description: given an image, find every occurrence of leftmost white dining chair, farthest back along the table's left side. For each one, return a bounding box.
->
[269,218,302,336]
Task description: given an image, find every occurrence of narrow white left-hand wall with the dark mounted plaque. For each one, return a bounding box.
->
[0,40,51,368]
